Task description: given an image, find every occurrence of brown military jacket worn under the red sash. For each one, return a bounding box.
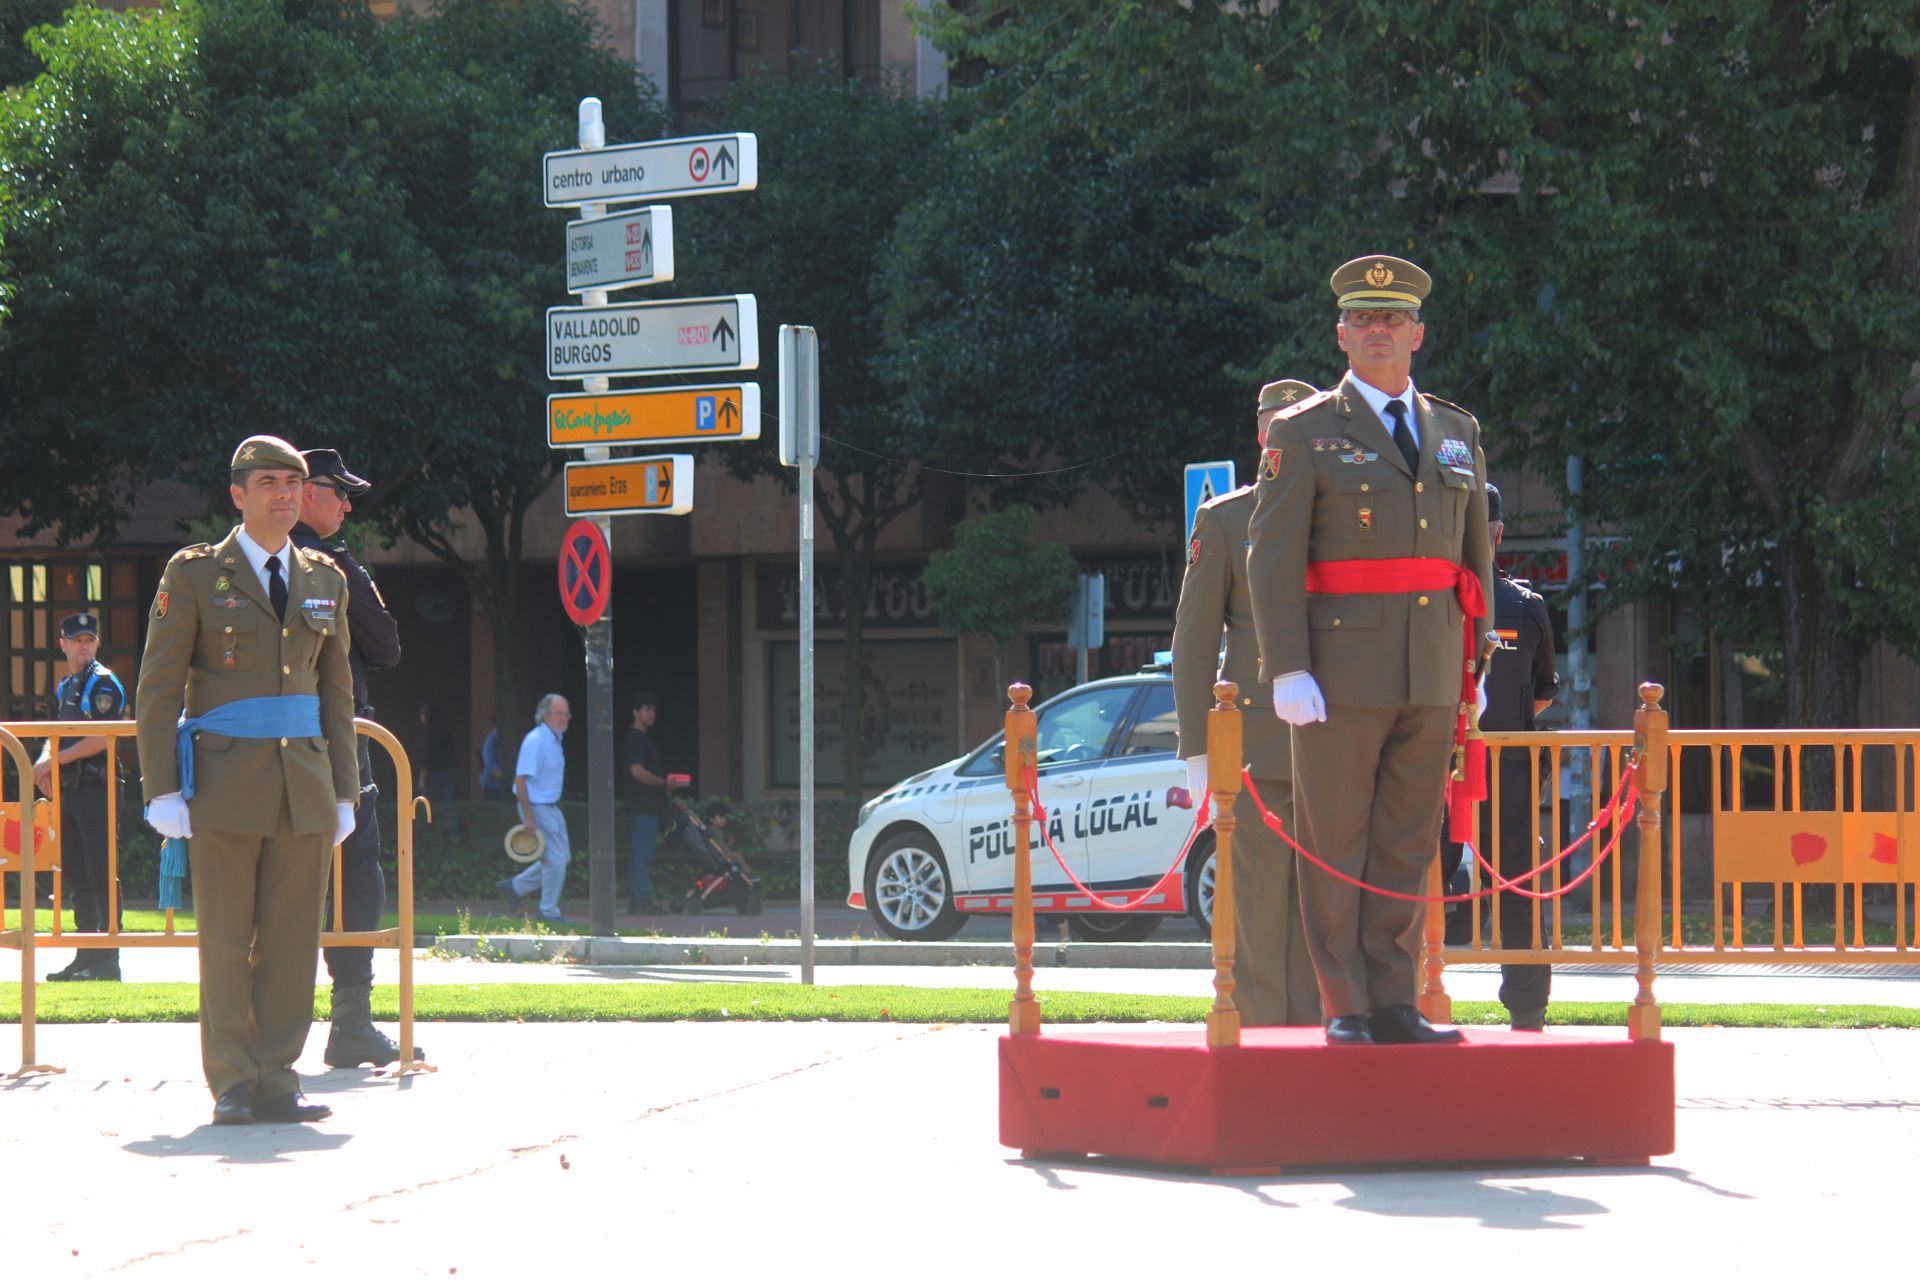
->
[1248,372,1494,708]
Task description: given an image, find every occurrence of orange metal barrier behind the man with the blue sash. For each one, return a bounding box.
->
[0,720,436,1079]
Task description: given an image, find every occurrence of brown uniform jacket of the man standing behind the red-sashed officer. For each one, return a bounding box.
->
[1173,486,1294,779]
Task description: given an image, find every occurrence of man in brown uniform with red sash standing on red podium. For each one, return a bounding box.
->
[1248,255,1494,1044]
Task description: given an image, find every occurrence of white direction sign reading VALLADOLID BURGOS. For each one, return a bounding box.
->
[547,294,760,378]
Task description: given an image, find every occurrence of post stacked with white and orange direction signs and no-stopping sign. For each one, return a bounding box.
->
[540,98,760,935]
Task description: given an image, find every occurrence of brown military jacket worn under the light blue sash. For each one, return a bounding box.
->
[138,528,359,837]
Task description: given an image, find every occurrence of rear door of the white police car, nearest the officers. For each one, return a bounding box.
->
[1087,681,1194,908]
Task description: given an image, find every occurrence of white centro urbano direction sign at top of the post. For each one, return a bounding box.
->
[540,132,760,209]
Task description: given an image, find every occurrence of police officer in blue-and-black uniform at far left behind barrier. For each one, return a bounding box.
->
[33,612,132,983]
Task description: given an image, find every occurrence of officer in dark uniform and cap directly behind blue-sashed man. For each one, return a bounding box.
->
[292,449,420,1067]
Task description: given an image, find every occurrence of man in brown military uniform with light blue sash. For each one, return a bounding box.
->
[138,436,359,1125]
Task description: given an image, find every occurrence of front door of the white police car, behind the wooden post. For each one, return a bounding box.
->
[952,685,1137,910]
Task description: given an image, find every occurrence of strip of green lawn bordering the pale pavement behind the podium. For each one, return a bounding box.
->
[0,983,1920,1029]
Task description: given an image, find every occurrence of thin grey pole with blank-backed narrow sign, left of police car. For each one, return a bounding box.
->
[780,324,820,986]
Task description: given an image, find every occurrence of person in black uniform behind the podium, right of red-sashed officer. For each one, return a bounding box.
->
[1442,486,1559,1031]
